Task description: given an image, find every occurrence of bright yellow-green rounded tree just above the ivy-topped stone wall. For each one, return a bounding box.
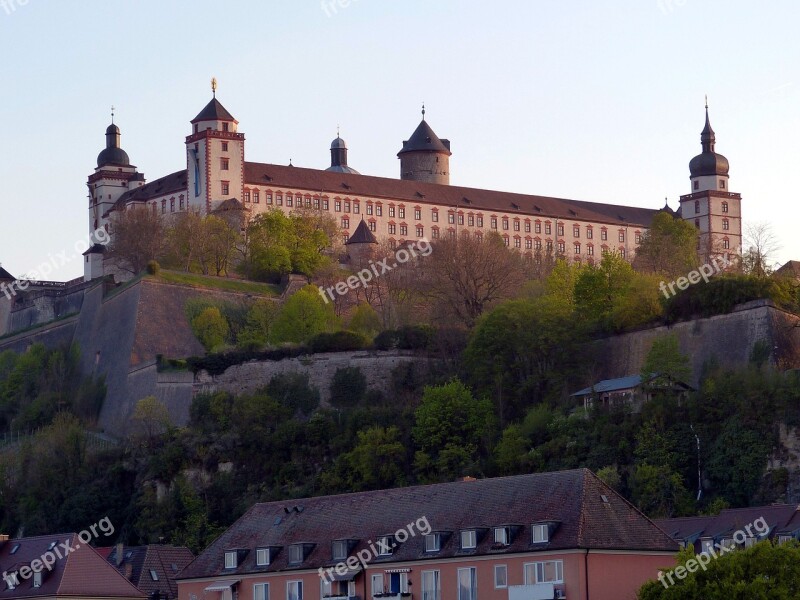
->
[272,285,336,343]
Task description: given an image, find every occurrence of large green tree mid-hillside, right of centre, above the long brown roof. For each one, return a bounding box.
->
[412,379,494,480]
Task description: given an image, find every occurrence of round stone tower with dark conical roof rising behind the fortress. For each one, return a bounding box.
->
[397,104,452,185]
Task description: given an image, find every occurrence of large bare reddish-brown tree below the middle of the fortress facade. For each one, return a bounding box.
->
[417,234,525,327]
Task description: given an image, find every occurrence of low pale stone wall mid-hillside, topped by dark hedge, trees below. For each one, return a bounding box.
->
[195,351,430,404]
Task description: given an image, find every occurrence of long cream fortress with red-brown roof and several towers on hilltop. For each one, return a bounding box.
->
[85,89,741,280]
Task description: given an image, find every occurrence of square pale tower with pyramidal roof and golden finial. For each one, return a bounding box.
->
[186,79,244,214]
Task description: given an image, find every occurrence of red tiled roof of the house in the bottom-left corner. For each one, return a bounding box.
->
[0,533,144,599]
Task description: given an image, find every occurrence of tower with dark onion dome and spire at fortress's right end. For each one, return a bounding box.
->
[680,103,742,262]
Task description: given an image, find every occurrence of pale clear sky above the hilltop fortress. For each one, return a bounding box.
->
[0,0,800,281]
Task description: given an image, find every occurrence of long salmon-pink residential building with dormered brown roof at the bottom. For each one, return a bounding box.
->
[178,469,678,600]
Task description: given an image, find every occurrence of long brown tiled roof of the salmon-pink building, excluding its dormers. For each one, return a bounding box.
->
[179,469,678,579]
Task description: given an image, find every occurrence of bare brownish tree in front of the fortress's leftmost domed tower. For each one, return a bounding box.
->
[106,207,165,275]
